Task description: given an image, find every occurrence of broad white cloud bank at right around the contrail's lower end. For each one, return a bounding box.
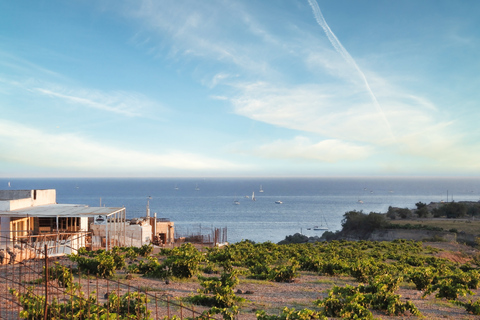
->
[232,79,480,170]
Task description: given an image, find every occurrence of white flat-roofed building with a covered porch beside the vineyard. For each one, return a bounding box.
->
[0,189,126,255]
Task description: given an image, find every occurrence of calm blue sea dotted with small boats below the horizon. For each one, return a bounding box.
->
[0,177,480,243]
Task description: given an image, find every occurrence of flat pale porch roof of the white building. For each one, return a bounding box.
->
[0,204,125,218]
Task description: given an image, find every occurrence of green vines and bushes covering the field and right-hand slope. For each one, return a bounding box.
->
[12,203,480,320]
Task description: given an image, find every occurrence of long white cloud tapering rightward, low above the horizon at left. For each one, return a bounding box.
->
[0,120,241,173]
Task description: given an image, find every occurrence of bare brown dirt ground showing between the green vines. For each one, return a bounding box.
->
[0,243,480,320]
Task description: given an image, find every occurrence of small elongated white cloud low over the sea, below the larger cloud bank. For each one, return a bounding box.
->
[254,136,373,163]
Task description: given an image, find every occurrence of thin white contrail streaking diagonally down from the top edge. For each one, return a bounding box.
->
[308,0,394,138]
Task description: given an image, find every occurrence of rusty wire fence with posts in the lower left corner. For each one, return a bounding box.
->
[0,234,219,319]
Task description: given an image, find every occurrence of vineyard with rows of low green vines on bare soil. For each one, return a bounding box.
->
[0,241,480,320]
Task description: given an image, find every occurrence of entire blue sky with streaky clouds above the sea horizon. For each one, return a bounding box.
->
[0,0,480,177]
